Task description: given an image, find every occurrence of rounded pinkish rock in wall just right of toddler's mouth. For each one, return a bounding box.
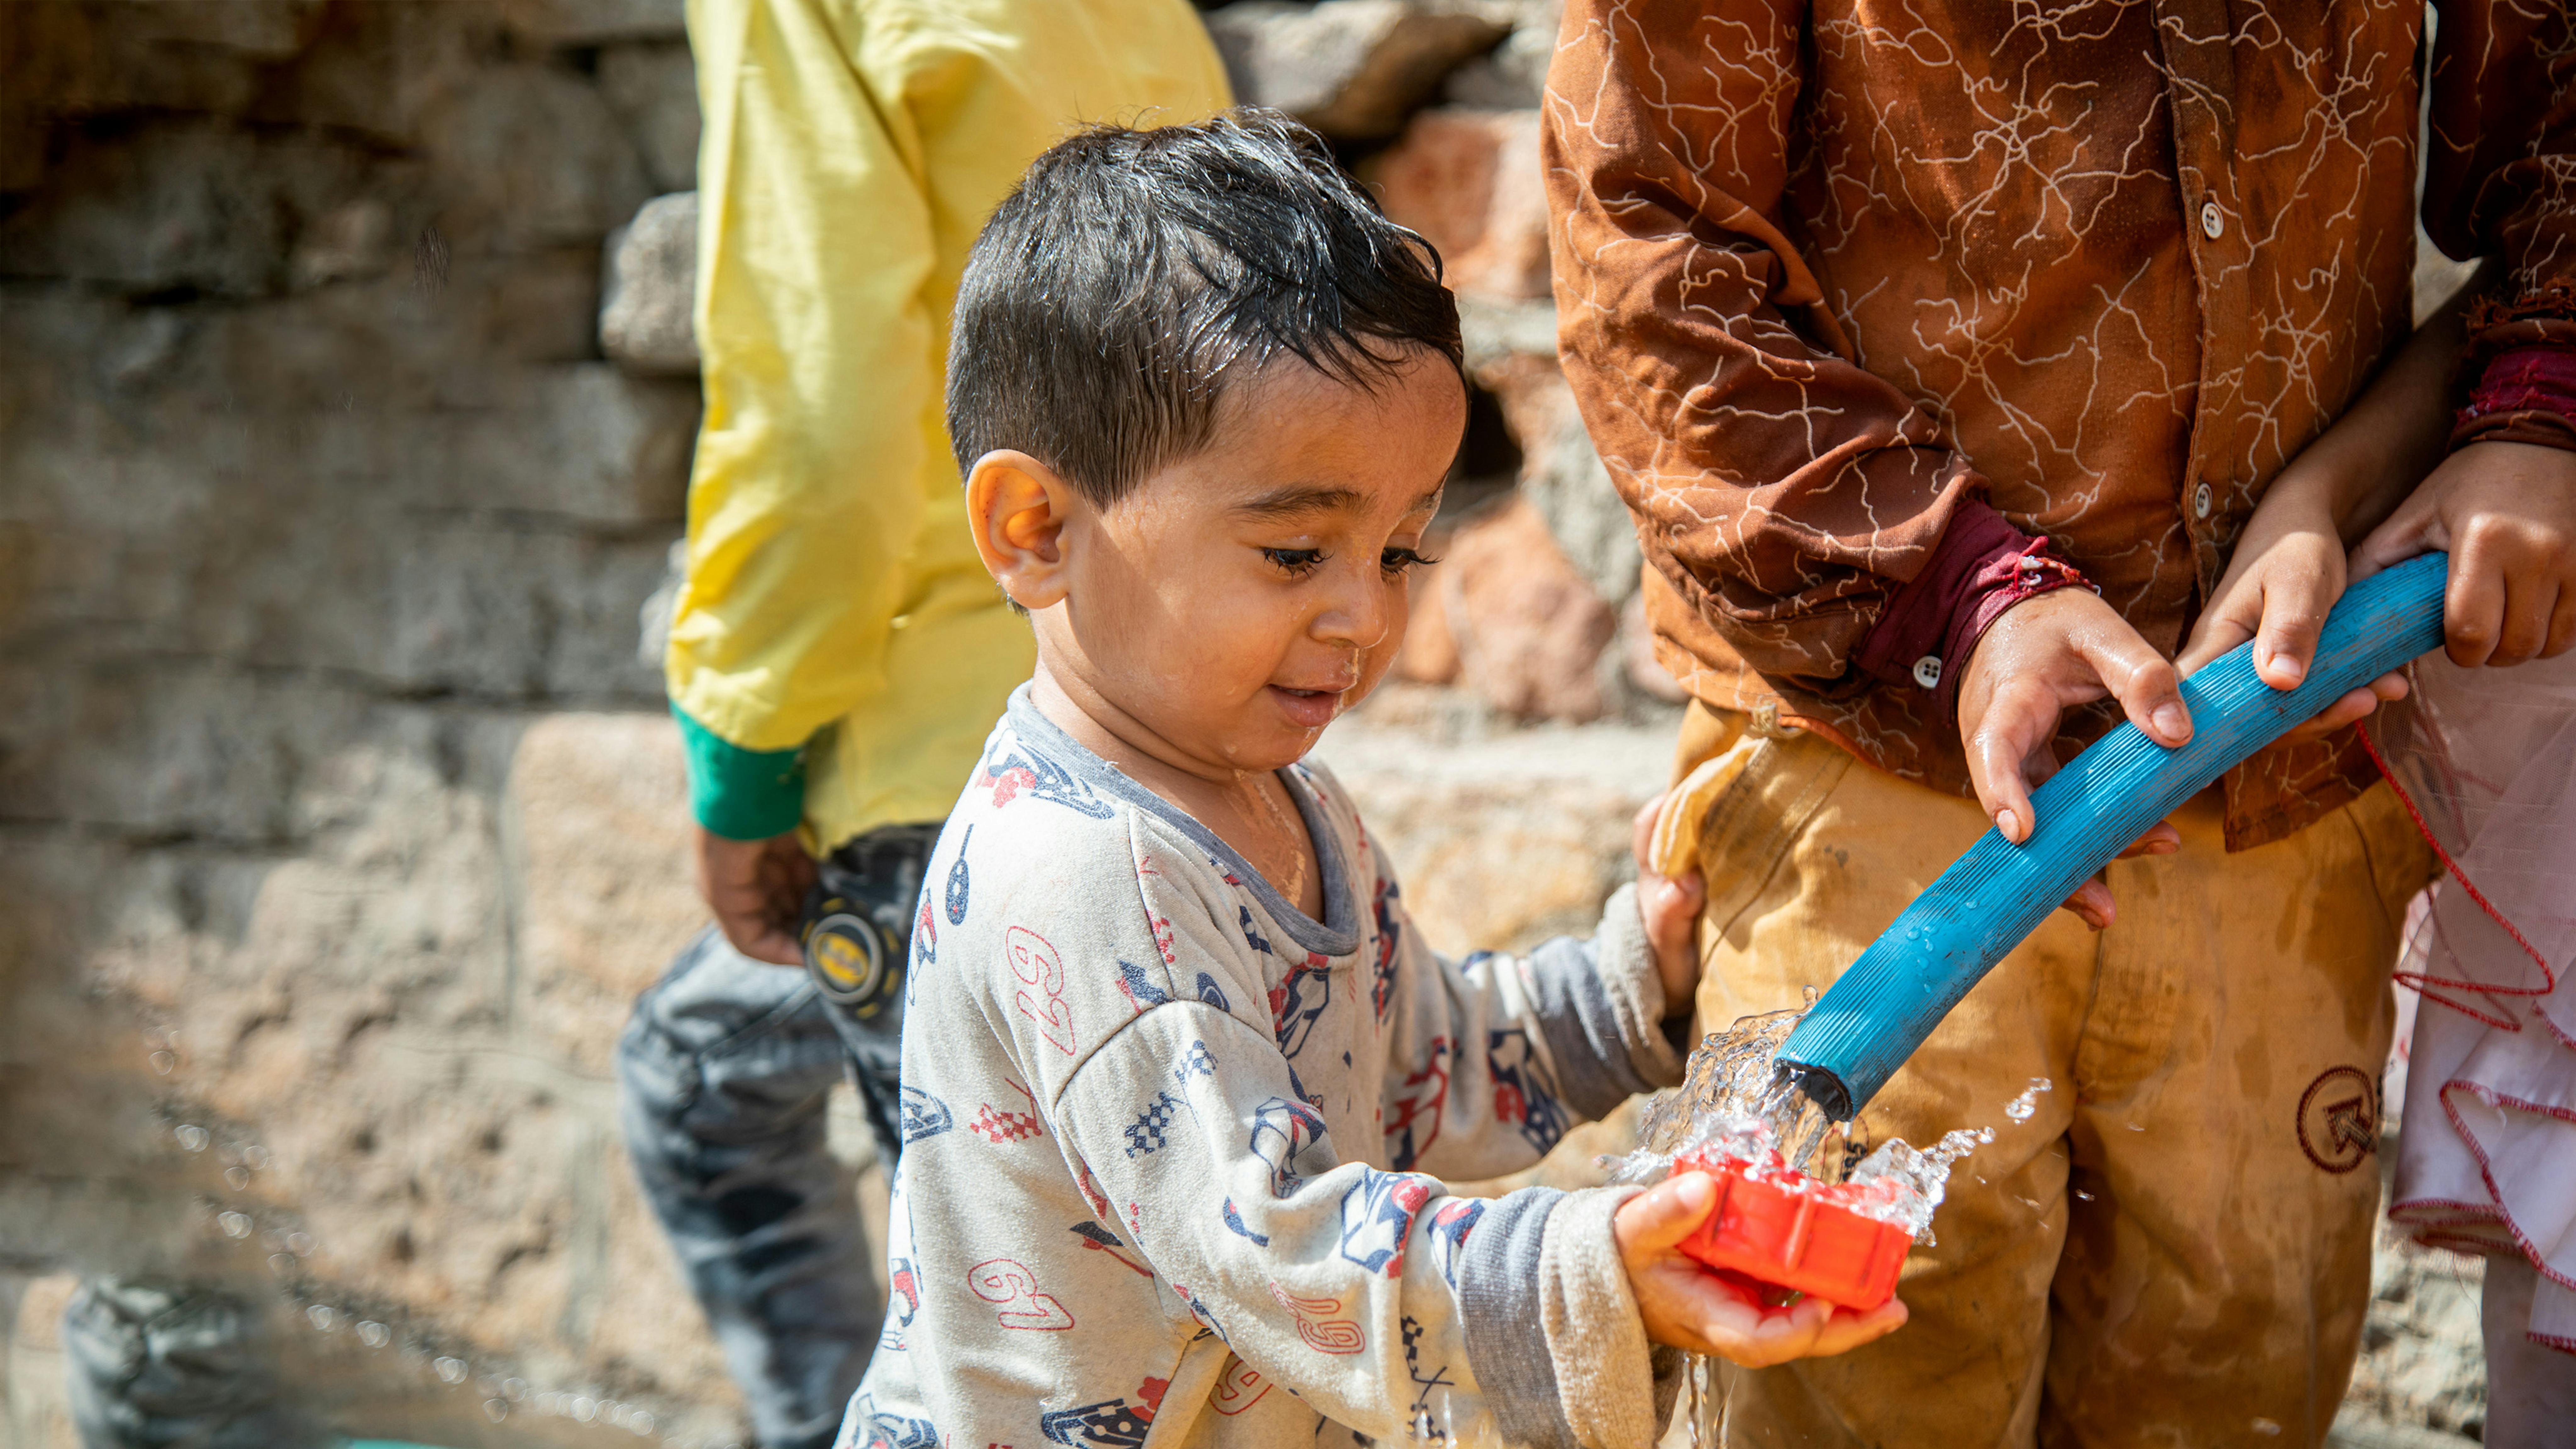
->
[1440,497,1618,722]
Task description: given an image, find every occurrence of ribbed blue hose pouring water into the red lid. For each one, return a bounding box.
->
[1780,554,2450,1122]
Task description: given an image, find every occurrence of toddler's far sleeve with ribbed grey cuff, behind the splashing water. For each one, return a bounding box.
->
[1378,877,1682,1178]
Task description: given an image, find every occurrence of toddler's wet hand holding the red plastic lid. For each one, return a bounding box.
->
[1610,1173,1906,1369]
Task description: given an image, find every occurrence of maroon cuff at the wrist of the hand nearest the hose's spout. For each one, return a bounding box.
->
[1852,497,2092,730]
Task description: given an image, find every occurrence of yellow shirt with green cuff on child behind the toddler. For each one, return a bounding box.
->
[667,0,1229,853]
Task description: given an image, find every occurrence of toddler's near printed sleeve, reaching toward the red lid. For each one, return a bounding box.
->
[1054,1000,1659,1449]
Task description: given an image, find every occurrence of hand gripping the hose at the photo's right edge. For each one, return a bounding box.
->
[2352,443,2576,668]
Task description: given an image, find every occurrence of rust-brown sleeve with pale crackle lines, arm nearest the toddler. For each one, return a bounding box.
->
[1541,0,2027,688]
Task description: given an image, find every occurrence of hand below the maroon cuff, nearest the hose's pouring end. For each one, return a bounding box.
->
[1958,588,2192,931]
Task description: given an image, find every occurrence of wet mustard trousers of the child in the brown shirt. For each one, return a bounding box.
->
[1679,707,2434,1449]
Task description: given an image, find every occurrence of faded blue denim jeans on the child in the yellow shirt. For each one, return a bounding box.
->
[618,825,938,1449]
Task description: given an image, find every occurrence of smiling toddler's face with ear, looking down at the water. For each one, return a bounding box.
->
[971,353,1466,774]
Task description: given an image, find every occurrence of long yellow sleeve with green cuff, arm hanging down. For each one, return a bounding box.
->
[665,0,943,838]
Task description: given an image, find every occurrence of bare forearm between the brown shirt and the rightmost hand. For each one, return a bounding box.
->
[2264,268,2486,547]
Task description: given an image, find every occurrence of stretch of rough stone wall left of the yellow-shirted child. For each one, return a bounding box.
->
[0,0,737,1444]
